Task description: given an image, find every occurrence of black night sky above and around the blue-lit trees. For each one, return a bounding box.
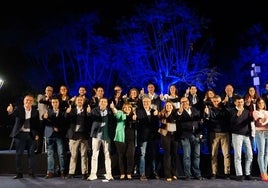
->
[0,0,268,101]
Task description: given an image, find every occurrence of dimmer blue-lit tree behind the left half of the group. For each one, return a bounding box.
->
[24,14,118,94]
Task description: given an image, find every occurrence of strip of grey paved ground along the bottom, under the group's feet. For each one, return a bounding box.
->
[0,174,268,188]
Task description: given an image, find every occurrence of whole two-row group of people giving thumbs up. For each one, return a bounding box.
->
[7,83,268,182]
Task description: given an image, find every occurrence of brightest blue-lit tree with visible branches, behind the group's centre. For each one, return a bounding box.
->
[112,0,219,92]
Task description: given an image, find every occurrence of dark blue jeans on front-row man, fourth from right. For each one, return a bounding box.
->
[181,135,201,177]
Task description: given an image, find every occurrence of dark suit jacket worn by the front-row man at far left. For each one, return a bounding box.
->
[10,105,40,139]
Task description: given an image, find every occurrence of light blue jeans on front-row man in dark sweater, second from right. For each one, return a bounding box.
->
[232,134,253,176]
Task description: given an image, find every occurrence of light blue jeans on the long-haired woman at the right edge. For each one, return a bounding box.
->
[255,131,268,174]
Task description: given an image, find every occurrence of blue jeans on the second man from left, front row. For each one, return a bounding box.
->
[46,137,65,173]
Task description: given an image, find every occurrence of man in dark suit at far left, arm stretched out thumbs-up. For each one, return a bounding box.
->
[7,94,40,179]
